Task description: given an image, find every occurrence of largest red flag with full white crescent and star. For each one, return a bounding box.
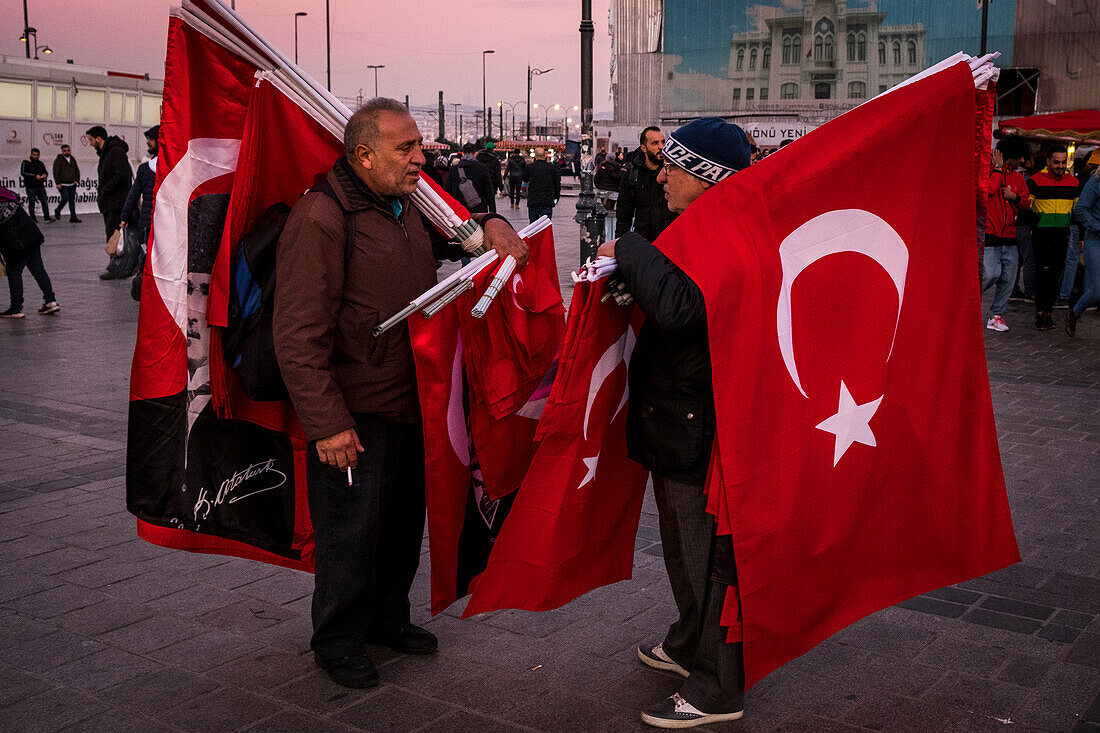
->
[656,63,1020,685]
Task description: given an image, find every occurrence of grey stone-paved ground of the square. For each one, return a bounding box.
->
[0,205,1100,733]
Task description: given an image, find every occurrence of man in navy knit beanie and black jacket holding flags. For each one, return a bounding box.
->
[600,118,749,727]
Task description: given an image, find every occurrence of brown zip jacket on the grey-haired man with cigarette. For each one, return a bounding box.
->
[274,157,462,440]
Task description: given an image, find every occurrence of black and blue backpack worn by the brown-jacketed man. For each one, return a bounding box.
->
[221,179,355,402]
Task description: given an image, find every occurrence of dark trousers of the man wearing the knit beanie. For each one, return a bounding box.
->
[653,473,745,713]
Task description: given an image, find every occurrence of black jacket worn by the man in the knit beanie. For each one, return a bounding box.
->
[615,233,716,485]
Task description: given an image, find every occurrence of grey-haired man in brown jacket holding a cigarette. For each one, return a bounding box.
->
[275,98,527,688]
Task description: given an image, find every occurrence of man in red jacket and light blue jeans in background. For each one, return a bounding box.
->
[981,136,1031,331]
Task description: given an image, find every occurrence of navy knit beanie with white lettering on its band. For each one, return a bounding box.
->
[661,117,749,184]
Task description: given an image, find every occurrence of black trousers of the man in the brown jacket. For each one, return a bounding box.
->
[306,415,425,659]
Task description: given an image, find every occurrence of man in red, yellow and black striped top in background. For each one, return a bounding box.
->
[1027,143,1077,331]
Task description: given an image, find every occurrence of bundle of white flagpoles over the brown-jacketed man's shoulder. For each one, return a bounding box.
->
[178,0,485,255]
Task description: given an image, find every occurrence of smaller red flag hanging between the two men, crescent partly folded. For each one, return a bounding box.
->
[463,281,647,616]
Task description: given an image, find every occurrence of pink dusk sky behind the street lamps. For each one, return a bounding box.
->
[0,0,612,117]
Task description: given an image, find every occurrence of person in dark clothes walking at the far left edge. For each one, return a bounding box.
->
[0,186,62,318]
